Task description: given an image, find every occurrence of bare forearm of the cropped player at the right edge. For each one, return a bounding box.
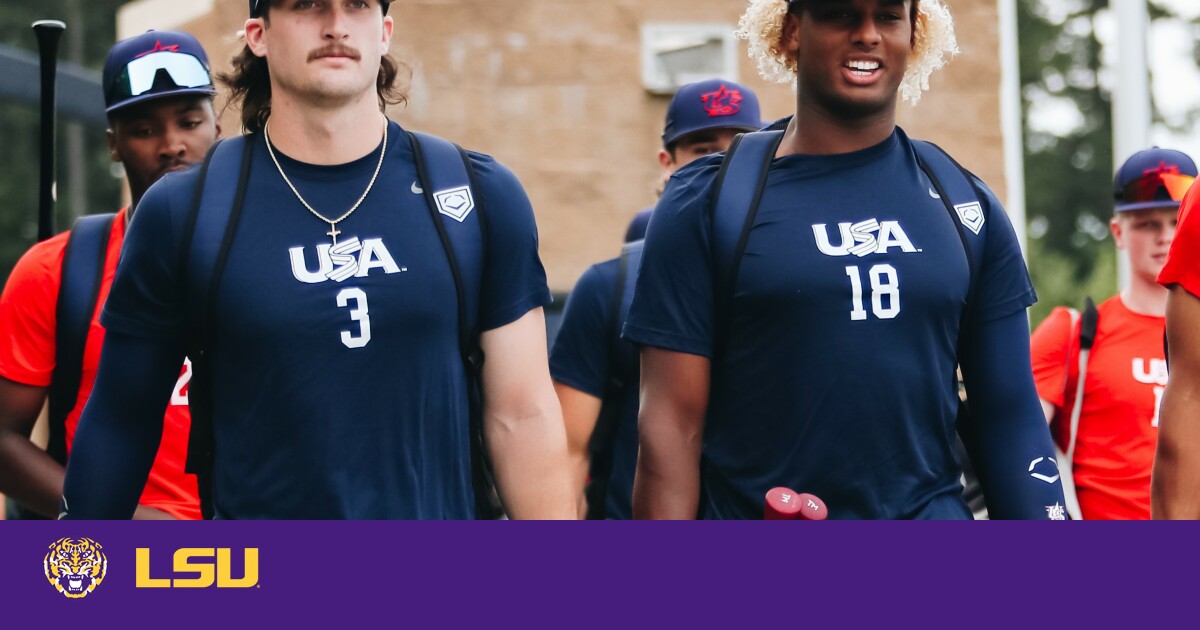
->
[1150,383,1200,520]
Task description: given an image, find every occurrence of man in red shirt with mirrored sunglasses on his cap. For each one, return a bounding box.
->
[0,31,221,518]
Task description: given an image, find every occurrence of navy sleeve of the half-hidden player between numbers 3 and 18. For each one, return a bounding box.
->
[550,262,617,398]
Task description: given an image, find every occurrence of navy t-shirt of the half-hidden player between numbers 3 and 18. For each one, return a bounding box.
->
[550,258,641,518]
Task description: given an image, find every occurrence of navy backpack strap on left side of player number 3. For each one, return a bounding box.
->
[180,136,258,518]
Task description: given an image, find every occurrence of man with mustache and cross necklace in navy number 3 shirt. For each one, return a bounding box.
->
[64,0,574,518]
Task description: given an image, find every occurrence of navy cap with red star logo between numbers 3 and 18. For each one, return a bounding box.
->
[662,79,763,146]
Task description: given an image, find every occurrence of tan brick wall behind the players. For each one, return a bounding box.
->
[122,0,1004,290]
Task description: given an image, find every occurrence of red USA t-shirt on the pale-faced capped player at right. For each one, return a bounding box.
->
[1030,295,1166,520]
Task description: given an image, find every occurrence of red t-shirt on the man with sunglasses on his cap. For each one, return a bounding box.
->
[0,209,200,518]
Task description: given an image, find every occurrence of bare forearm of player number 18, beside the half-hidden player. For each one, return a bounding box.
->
[634,415,701,520]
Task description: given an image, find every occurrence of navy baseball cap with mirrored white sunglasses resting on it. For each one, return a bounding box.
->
[104,30,217,114]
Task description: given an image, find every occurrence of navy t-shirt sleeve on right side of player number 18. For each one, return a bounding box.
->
[971,179,1038,323]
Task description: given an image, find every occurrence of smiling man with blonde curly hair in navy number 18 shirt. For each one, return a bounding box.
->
[624,0,1063,518]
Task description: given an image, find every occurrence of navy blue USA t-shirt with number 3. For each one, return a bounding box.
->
[102,122,550,518]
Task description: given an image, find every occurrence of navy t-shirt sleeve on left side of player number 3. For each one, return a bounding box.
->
[101,169,188,341]
